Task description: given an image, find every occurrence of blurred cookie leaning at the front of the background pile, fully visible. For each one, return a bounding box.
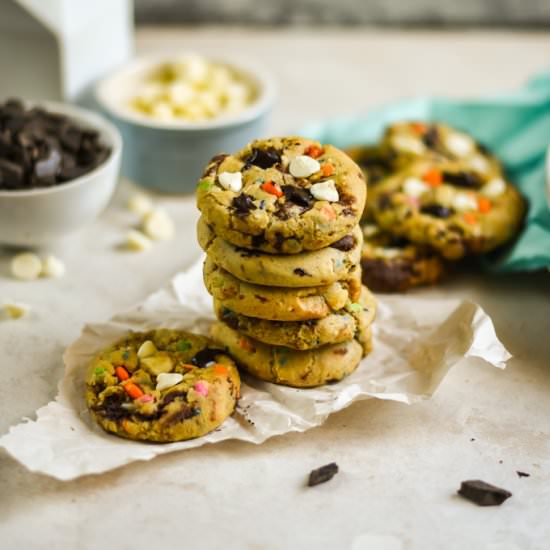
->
[367,161,525,260]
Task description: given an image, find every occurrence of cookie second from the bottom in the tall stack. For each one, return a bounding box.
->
[214,287,376,350]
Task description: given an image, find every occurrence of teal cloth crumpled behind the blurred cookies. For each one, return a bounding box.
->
[300,72,550,272]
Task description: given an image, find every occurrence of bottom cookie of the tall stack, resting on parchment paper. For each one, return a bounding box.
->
[210,321,372,388]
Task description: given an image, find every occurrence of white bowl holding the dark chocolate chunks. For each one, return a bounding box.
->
[0,101,122,246]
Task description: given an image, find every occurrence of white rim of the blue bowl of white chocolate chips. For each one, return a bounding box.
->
[94,51,277,131]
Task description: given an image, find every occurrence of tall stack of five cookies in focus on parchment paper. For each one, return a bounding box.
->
[197,137,375,387]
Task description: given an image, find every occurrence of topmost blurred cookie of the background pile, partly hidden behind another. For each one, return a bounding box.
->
[380,122,502,177]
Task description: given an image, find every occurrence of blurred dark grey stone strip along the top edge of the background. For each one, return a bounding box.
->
[135,0,550,27]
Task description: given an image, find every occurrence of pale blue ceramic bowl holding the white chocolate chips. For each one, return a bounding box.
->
[96,56,275,193]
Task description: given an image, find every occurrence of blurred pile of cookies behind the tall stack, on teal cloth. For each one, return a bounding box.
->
[347,122,525,292]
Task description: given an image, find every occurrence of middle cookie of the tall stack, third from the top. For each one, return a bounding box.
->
[203,258,361,321]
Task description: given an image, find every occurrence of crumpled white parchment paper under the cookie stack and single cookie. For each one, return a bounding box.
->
[0,262,510,480]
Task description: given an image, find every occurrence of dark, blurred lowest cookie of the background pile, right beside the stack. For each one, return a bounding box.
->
[361,223,445,292]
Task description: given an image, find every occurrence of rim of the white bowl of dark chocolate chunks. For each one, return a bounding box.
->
[0,99,122,199]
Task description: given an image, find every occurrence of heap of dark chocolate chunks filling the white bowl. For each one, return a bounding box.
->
[0,99,110,190]
